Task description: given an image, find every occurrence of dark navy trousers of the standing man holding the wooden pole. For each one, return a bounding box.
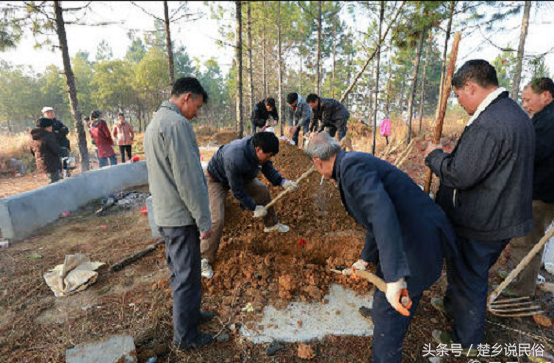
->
[444,236,509,349]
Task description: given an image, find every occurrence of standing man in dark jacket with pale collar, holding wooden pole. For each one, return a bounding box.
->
[425,60,535,349]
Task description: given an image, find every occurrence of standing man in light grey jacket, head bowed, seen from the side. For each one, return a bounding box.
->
[144,77,214,350]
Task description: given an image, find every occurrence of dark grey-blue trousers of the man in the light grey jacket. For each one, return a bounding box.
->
[159,225,202,344]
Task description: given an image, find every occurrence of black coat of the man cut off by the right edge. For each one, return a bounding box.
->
[531,101,554,203]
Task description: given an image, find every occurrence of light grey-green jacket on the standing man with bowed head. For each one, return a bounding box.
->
[143,101,212,232]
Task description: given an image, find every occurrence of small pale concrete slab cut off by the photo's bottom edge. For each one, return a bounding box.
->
[65,335,137,363]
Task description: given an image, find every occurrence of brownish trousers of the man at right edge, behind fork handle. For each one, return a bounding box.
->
[508,200,554,296]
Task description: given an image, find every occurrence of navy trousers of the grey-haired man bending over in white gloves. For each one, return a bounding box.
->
[372,289,421,363]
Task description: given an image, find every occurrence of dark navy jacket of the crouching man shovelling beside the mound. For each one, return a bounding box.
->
[208,136,283,211]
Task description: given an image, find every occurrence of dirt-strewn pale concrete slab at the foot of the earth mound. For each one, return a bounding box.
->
[240,284,373,344]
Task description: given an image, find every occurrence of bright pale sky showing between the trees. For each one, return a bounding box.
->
[0,1,554,82]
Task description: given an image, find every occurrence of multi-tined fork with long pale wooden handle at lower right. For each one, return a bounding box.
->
[487,227,554,317]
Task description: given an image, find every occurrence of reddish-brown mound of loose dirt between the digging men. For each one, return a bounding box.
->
[203,142,370,312]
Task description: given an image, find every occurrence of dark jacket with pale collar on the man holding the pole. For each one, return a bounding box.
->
[425,92,535,241]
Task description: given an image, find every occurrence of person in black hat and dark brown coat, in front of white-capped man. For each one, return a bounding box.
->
[31,117,60,183]
